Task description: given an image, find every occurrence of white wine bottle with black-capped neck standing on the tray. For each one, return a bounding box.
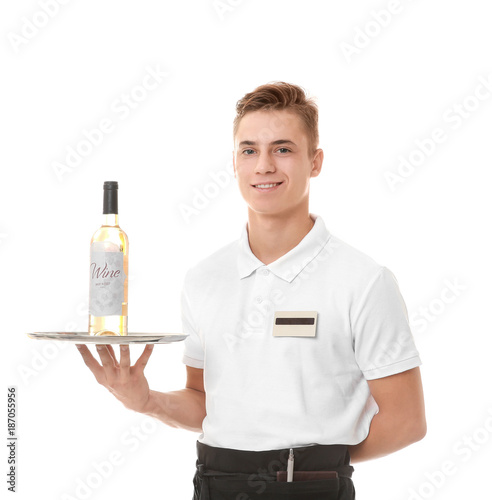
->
[89,181,128,335]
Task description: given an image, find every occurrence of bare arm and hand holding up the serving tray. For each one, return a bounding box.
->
[77,344,206,432]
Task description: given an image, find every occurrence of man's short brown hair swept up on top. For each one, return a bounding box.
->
[233,82,319,154]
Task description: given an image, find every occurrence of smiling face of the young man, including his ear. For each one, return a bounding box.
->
[233,110,323,215]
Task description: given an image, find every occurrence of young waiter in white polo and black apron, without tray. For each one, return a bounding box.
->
[80,82,426,500]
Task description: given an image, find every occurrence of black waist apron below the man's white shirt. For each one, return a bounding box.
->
[193,441,355,500]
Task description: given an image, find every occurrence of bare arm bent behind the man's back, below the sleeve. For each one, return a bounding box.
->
[349,367,427,463]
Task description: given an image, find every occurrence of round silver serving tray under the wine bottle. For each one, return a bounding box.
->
[27,332,188,345]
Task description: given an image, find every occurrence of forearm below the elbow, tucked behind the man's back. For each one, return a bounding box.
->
[349,412,426,463]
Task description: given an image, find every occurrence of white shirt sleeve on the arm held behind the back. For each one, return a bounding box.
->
[352,266,422,380]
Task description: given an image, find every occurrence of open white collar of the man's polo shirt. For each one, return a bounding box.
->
[237,214,331,283]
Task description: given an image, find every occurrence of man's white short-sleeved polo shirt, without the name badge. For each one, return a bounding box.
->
[181,214,421,451]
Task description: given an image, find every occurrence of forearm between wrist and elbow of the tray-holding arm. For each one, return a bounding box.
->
[141,388,206,432]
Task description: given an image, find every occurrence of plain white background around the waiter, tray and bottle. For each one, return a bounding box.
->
[0,0,492,500]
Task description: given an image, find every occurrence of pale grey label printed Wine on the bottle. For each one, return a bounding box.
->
[89,251,126,316]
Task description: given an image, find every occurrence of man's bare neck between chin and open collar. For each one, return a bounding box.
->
[248,207,314,265]
